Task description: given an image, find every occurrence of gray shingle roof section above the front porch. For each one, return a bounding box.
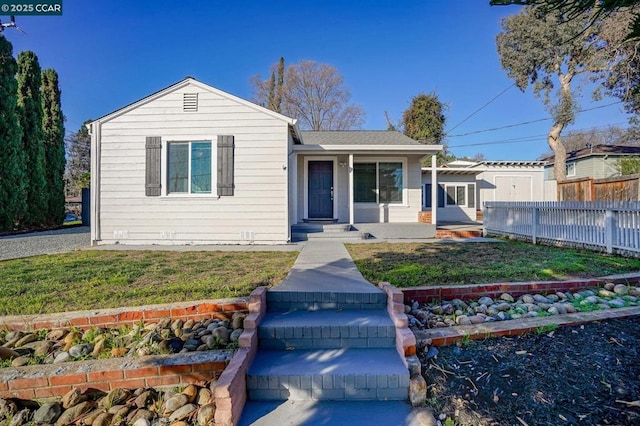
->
[300,130,422,145]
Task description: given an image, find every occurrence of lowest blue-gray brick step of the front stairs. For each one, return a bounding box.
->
[247,348,409,401]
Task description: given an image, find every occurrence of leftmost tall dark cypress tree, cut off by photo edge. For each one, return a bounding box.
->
[0,35,26,231]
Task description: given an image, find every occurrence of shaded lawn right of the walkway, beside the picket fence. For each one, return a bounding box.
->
[347,241,640,287]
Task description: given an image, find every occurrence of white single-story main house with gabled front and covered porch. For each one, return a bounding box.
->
[89,78,442,244]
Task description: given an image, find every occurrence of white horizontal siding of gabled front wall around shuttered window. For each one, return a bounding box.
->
[97,84,289,244]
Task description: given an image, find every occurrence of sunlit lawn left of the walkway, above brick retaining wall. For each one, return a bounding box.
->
[0,251,297,315]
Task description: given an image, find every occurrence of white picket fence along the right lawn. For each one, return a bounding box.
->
[483,201,640,256]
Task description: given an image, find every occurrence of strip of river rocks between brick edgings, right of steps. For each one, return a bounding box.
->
[405,283,640,329]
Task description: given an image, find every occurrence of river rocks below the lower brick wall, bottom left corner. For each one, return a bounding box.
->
[0,381,216,426]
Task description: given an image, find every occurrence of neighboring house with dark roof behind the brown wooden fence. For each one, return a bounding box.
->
[544,145,640,180]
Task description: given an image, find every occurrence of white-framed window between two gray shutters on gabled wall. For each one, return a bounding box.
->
[167,140,213,194]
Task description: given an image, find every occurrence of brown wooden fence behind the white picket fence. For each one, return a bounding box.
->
[558,175,640,202]
